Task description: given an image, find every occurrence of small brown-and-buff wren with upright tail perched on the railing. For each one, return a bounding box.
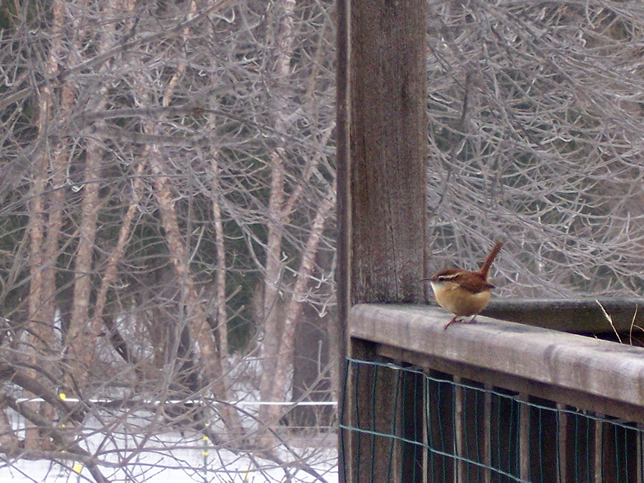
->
[426,242,503,329]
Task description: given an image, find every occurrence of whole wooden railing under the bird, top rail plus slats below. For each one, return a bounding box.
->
[341,302,644,482]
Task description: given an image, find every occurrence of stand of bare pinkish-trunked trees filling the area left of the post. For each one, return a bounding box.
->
[0,0,335,481]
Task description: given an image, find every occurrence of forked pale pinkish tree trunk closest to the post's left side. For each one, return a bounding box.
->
[260,0,335,432]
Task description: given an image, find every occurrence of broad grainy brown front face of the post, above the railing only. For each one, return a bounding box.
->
[350,0,427,303]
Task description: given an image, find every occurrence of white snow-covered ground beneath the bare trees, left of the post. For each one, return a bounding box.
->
[0,412,338,483]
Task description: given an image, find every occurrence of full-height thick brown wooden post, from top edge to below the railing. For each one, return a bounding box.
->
[337,0,427,482]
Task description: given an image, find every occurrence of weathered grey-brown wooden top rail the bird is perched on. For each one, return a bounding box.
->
[350,304,644,406]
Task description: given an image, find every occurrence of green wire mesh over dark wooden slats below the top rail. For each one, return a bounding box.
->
[341,358,643,482]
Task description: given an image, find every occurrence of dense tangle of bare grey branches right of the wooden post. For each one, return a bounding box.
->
[428,1,644,296]
